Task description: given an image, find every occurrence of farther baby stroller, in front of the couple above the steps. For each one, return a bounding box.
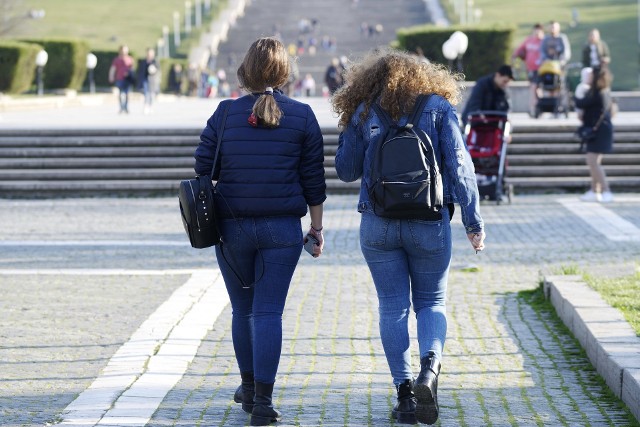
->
[534,60,569,118]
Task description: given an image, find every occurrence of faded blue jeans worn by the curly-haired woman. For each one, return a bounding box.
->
[360,209,451,385]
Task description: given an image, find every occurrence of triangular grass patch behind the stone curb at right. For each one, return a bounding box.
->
[583,273,640,337]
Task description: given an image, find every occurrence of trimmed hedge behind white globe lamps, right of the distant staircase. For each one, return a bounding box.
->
[395,25,516,81]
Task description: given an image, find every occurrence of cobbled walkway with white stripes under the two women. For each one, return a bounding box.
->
[0,194,640,426]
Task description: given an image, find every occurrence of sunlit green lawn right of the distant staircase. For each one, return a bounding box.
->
[441,0,640,90]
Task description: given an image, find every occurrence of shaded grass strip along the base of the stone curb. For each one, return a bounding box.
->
[518,283,640,427]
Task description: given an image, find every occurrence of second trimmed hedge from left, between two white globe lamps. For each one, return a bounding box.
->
[24,39,89,90]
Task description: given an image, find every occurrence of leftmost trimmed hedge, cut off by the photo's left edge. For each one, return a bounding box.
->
[0,41,42,94]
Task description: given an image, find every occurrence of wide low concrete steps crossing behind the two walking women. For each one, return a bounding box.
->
[0,126,640,198]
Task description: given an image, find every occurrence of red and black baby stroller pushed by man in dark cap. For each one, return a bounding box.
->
[464,111,513,204]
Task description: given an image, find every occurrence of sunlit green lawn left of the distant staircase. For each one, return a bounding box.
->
[14,0,220,56]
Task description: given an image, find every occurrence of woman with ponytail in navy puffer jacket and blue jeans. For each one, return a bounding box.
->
[195,37,326,425]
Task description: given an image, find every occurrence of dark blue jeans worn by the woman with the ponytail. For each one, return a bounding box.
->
[216,217,303,384]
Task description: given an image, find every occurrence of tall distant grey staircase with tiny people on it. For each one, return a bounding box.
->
[216,0,430,89]
